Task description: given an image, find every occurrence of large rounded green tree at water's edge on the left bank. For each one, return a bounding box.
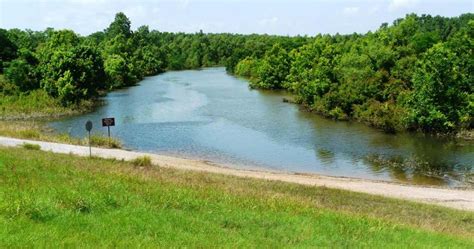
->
[38,30,105,105]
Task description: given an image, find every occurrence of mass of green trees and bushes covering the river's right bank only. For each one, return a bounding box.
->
[246,14,474,133]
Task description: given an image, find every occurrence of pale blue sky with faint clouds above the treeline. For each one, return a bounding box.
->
[0,0,474,36]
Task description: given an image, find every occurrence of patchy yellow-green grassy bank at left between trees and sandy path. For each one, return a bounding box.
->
[0,74,122,148]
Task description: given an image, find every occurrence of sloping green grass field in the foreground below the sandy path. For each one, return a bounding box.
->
[0,147,474,248]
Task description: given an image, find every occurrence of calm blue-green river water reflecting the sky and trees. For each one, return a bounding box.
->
[51,68,474,186]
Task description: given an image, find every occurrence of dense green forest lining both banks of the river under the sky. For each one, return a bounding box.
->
[0,13,474,133]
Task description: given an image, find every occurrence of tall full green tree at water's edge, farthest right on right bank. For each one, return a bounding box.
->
[409,44,472,132]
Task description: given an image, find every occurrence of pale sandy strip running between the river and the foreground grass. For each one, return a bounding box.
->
[0,137,474,211]
